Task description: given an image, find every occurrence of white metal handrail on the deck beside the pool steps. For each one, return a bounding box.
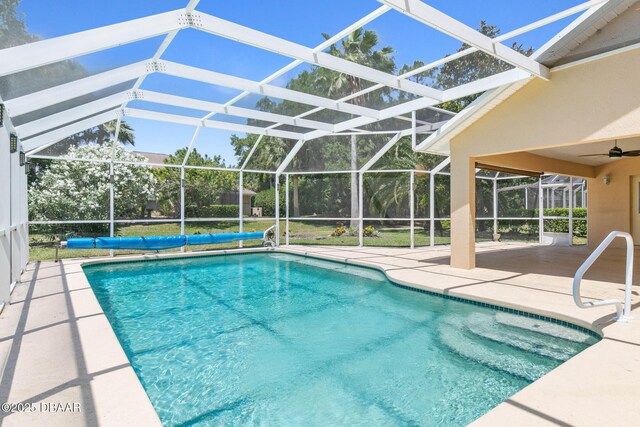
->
[573,231,633,322]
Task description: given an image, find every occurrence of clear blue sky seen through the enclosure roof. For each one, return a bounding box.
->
[19,0,582,165]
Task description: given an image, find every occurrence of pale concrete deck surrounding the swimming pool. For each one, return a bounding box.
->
[0,243,640,426]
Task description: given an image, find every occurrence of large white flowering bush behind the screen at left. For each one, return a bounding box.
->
[29,144,157,226]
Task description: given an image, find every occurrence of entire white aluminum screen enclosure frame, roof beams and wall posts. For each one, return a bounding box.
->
[0,0,607,260]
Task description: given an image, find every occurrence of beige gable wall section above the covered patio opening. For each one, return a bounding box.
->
[451,49,640,156]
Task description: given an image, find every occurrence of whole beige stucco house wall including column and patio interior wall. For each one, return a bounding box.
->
[450,49,640,268]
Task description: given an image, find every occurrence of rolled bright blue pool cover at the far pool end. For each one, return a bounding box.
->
[67,231,264,251]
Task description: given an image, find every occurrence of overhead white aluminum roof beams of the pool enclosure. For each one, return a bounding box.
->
[6,0,605,154]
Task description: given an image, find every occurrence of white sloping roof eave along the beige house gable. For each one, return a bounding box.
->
[417,0,640,155]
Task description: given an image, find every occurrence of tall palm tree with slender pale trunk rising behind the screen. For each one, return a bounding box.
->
[319,28,396,227]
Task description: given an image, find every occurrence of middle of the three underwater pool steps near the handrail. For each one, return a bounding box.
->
[464,315,585,362]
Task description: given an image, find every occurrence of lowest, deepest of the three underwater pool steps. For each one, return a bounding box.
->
[438,319,559,382]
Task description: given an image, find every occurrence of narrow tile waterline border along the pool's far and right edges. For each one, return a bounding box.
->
[81,248,603,340]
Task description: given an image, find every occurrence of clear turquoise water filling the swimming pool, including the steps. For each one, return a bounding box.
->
[85,253,597,426]
